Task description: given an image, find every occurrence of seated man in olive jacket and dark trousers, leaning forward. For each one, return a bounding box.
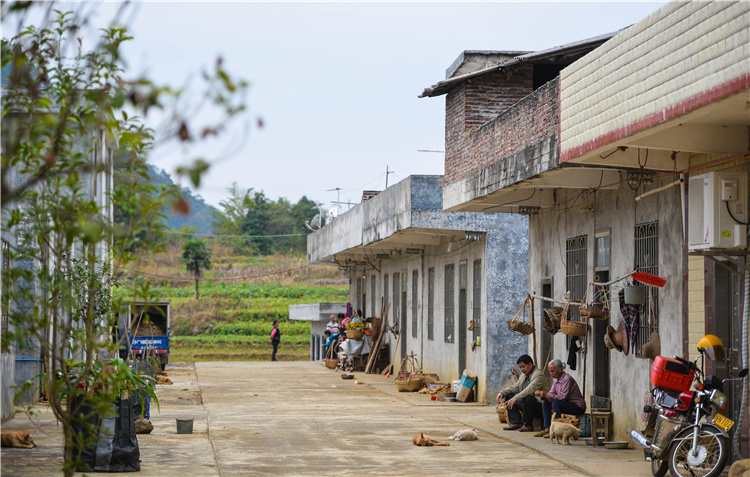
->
[497,354,550,432]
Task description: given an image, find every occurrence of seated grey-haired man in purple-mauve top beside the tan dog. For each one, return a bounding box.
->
[535,359,586,437]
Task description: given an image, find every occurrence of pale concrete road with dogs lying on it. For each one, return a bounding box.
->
[2,362,650,477]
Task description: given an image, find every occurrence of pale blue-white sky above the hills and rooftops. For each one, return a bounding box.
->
[3,1,664,211]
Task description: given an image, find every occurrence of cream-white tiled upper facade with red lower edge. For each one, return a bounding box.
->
[560,1,750,156]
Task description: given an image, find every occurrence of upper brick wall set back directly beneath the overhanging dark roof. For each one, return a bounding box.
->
[445,65,533,182]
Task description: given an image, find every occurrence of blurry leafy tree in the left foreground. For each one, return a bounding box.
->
[0,2,247,475]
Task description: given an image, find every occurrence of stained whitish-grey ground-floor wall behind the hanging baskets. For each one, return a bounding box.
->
[529,178,686,440]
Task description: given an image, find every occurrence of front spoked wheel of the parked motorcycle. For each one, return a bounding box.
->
[669,427,729,477]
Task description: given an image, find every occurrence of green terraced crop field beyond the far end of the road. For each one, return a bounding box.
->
[115,268,348,362]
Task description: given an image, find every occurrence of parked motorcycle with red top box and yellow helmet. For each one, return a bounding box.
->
[630,335,748,477]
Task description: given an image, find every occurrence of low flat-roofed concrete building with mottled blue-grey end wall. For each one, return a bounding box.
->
[307,176,528,401]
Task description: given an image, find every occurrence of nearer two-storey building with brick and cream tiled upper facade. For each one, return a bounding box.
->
[423,2,750,446]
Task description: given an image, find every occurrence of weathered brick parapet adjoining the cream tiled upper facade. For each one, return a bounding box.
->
[445,72,560,184]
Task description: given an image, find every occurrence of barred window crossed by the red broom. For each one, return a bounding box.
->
[633,222,659,356]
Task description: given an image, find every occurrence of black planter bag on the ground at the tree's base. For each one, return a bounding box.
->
[68,395,141,472]
